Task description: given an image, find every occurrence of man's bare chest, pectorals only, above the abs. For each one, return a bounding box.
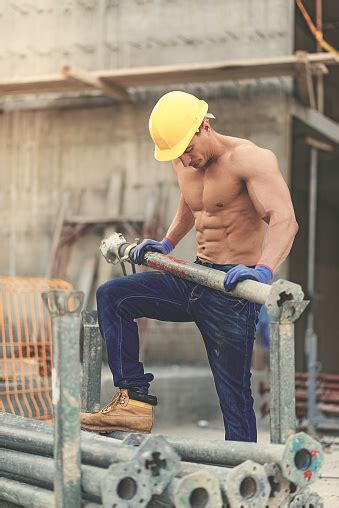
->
[177,167,244,213]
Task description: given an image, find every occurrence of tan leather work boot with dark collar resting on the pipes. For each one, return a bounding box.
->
[80,388,157,433]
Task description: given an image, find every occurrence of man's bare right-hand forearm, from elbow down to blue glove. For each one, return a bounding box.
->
[257,217,298,272]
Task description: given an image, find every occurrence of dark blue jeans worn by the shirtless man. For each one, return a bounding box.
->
[97,260,260,441]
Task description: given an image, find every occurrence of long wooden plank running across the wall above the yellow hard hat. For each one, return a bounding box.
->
[0,53,339,96]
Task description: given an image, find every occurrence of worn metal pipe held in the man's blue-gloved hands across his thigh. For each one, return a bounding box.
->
[100,233,304,315]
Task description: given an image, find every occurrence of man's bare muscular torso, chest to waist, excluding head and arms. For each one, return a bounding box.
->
[174,136,265,265]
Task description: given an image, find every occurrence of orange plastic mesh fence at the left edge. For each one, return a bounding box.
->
[0,277,73,420]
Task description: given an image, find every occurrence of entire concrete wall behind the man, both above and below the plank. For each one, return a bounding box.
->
[0,0,294,283]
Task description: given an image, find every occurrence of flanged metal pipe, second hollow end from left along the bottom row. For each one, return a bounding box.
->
[148,471,223,508]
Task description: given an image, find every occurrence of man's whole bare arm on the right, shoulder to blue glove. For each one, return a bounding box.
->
[234,145,298,272]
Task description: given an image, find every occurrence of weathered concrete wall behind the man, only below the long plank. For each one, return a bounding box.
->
[0,89,289,282]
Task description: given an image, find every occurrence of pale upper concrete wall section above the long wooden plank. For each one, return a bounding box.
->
[0,0,294,79]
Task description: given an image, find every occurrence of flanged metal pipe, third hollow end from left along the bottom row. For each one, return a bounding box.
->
[181,460,271,508]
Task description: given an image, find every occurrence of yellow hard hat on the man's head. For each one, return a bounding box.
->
[149,91,212,161]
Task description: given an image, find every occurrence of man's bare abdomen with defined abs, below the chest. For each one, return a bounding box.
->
[193,205,265,265]
